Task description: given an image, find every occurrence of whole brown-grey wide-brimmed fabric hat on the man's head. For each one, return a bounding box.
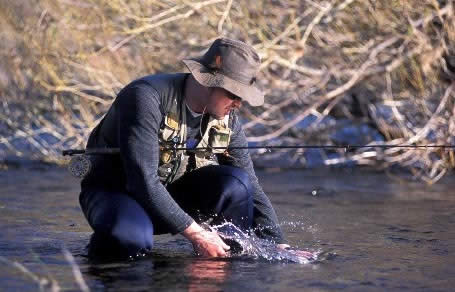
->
[183,38,264,106]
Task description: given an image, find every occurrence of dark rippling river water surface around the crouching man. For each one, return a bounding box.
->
[0,169,455,291]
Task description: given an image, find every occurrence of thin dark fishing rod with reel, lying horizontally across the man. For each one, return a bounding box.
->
[62,144,455,156]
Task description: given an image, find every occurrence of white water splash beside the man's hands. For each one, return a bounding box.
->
[210,222,320,264]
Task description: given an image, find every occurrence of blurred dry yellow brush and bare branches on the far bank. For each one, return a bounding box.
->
[0,0,455,183]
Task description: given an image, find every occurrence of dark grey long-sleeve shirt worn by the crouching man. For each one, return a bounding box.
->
[81,74,284,243]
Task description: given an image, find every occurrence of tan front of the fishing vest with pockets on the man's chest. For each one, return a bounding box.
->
[158,98,231,185]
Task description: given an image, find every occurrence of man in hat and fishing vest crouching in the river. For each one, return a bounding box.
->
[80,38,288,257]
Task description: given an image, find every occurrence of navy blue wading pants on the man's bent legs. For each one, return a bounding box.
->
[79,165,253,258]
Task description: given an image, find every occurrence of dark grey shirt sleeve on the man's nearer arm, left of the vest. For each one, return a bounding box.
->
[115,83,194,234]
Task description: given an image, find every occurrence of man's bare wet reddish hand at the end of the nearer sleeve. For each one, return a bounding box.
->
[182,222,230,257]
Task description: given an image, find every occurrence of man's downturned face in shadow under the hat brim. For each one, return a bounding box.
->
[206,87,242,120]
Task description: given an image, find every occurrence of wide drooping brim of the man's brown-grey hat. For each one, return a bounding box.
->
[182,59,264,106]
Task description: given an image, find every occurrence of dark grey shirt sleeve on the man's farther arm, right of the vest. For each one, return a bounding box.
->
[219,113,286,243]
